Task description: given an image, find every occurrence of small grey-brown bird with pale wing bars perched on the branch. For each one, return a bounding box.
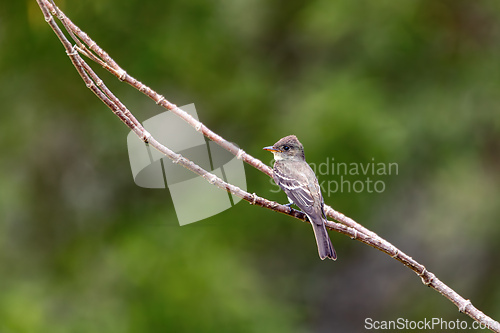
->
[263,135,337,260]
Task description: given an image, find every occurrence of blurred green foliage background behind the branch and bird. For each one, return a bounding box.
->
[0,0,500,333]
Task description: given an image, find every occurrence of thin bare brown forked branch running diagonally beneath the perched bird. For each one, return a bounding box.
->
[37,0,500,333]
